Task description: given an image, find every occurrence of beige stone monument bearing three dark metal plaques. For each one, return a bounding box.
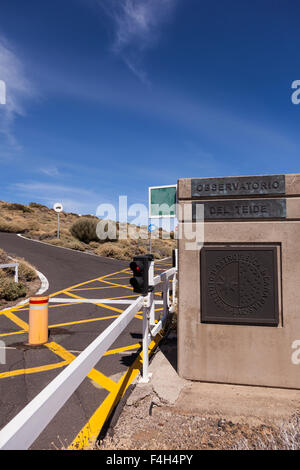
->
[178,174,300,388]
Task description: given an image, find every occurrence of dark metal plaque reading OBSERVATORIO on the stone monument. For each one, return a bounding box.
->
[191,175,285,198]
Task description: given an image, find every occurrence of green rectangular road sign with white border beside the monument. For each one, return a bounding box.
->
[149,185,177,219]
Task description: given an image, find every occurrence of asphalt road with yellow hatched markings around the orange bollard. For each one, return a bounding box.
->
[0,233,167,449]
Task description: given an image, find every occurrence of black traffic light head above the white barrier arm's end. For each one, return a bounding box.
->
[129,255,154,295]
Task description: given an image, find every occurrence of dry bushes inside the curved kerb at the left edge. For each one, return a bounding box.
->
[0,249,40,309]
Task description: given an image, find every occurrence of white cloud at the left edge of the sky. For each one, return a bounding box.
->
[0,36,35,149]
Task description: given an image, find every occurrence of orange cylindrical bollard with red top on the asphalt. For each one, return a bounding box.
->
[28,295,49,345]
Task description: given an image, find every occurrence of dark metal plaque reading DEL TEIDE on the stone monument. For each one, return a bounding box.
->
[192,199,286,222]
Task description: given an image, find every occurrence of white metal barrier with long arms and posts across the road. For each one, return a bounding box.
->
[0,268,177,450]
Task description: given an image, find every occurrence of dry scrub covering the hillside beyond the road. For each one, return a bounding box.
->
[0,201,176,260]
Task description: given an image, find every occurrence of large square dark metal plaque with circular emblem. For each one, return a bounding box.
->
[201,246,279,326]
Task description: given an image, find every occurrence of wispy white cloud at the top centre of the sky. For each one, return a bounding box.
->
[98,0,177,83]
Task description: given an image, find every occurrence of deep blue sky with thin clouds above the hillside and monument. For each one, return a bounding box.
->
[0,0,300,217]
